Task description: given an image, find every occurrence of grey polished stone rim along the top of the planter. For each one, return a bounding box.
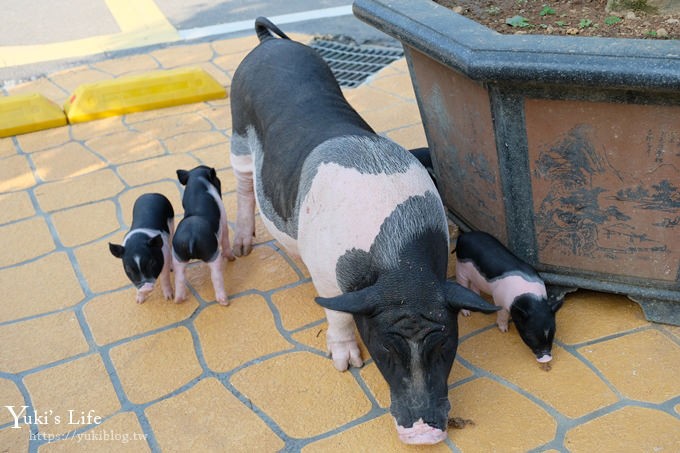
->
[353,0,680,92]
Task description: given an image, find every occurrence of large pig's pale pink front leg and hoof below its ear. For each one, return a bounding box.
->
[324,308,364,371]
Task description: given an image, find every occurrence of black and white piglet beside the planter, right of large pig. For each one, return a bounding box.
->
[456,231,564,363]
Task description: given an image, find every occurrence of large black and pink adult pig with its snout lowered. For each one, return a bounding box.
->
[230,18,497,444]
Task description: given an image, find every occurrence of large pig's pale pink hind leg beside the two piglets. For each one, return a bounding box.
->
[232,162,255,256]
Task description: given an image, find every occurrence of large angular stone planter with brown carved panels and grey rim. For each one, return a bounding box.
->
[354,0,680,324]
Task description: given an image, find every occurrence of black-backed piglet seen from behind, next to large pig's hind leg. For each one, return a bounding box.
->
[172,165,235,305]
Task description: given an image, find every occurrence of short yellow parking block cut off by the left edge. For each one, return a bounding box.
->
[0,93,66,137]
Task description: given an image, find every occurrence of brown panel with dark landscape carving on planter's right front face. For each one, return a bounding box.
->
[525,99,680,283]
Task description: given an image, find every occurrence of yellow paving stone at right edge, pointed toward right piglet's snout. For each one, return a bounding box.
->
[576,330,680,403]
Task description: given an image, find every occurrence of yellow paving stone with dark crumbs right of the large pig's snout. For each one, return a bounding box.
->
[449,378,557,453]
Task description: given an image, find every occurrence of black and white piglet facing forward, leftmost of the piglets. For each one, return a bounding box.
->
[109,193,175,304]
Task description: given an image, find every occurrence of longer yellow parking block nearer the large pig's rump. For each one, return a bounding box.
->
[64,68,227,123]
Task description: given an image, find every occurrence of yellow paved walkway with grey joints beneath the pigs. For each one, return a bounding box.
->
[0,31,680,452]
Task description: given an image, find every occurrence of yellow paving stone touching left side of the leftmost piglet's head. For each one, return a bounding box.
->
[74,240,134,294]
